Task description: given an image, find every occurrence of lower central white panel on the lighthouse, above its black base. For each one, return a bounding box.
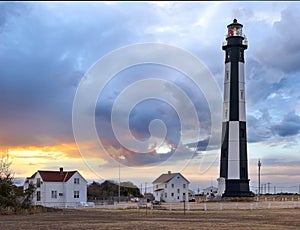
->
[228,121,240,179]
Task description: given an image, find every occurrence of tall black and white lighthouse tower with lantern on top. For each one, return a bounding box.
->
[219,19,252,197]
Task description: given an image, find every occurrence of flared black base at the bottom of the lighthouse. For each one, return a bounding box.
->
[223,179,254,197]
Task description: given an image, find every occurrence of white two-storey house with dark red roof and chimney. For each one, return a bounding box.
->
[24,168,87,207]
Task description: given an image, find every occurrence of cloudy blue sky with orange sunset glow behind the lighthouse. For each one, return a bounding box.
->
[0,1,300,192]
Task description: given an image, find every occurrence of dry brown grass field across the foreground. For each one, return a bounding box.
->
[0,208,300,230]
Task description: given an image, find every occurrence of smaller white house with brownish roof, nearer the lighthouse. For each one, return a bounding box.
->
[152,171,190,202]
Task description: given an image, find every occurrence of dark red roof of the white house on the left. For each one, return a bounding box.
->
[31,170,77,182]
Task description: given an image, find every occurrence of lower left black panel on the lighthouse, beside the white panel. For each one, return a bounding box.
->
[220,121,229,178]
